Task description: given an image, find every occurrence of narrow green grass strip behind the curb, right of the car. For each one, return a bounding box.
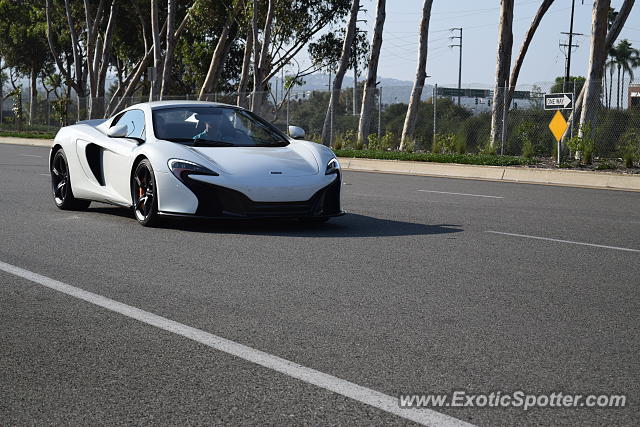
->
[334,150,538,166]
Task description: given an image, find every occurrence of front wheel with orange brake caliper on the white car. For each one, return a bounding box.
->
[131,159,160,227]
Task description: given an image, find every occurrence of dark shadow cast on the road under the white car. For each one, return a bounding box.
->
[89,207,464,237]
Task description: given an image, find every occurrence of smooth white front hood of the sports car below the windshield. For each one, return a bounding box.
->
[190,145,319,177]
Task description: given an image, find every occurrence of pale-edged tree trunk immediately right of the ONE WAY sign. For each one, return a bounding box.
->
[580,0,615,135]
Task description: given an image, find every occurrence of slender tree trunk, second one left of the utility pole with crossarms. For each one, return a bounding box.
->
[358,0,386,146]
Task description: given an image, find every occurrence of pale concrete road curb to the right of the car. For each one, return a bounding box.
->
[339,157,640,191]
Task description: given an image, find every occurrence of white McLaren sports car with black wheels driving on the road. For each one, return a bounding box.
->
[49,101,343,226]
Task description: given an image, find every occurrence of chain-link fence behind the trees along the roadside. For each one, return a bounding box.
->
[0,82,640,164]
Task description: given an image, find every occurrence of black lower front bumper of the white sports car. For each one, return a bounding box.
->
[160,173,344,219]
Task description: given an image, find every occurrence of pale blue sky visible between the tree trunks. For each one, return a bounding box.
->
[304,0,640,88]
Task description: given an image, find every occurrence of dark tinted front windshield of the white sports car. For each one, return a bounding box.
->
[153,106,289,147]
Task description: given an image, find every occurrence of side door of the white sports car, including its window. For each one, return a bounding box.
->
[102,110,146,203]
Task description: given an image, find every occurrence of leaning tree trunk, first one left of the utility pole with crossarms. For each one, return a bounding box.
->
[400,0,433,150]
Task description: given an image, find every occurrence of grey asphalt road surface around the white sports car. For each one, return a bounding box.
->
[0,145,640,425]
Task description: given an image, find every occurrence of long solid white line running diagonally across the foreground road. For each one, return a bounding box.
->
[0,261,472,426]
